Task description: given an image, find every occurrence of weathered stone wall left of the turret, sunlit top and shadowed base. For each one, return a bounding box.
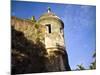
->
[11,17,47,74]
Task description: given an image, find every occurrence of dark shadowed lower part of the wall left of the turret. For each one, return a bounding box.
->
[11,27,47,75]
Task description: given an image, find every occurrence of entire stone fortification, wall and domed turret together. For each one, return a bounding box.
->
[11,9,70,74]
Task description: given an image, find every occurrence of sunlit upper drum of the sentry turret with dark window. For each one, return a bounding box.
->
[38,15,64,48]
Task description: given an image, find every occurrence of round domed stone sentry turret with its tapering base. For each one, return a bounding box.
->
[38,8,70,71]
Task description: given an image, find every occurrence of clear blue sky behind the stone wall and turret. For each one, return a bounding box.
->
[11,1,96,69]
